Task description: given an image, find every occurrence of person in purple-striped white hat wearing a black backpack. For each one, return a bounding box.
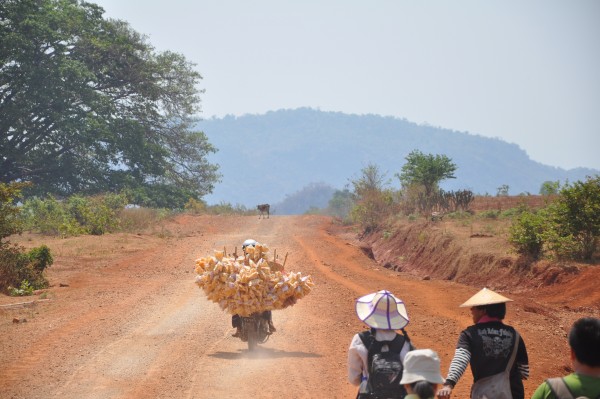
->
[348,290,414,398]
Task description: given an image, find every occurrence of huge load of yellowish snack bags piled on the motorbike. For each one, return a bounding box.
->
[196,244,314,316]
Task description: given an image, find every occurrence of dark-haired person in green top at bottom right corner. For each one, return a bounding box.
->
[531,317,600,399]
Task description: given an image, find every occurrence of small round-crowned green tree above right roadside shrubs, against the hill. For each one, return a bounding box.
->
[396,150,456,198]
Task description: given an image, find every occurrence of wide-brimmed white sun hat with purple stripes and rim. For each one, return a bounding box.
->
[356,290,409,330]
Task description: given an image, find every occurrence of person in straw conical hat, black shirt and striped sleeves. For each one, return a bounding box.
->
[438,288,529,399]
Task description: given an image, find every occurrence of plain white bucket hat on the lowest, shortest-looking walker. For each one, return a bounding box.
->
[400,349,445,385]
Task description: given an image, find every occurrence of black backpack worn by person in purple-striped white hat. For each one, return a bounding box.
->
[358,330,412,399]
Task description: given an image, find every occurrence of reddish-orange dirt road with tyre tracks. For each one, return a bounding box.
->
[0,216,598,399]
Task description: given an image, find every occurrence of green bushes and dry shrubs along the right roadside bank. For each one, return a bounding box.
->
[326,151,600,264]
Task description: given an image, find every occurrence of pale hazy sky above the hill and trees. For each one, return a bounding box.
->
[95,0,600,170]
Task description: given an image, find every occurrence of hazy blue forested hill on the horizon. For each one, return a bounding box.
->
[198,108,599,214]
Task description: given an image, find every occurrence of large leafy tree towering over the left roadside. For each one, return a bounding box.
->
[0,0,219,206]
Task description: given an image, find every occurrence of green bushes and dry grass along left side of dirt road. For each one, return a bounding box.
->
[0,182,256,296]
